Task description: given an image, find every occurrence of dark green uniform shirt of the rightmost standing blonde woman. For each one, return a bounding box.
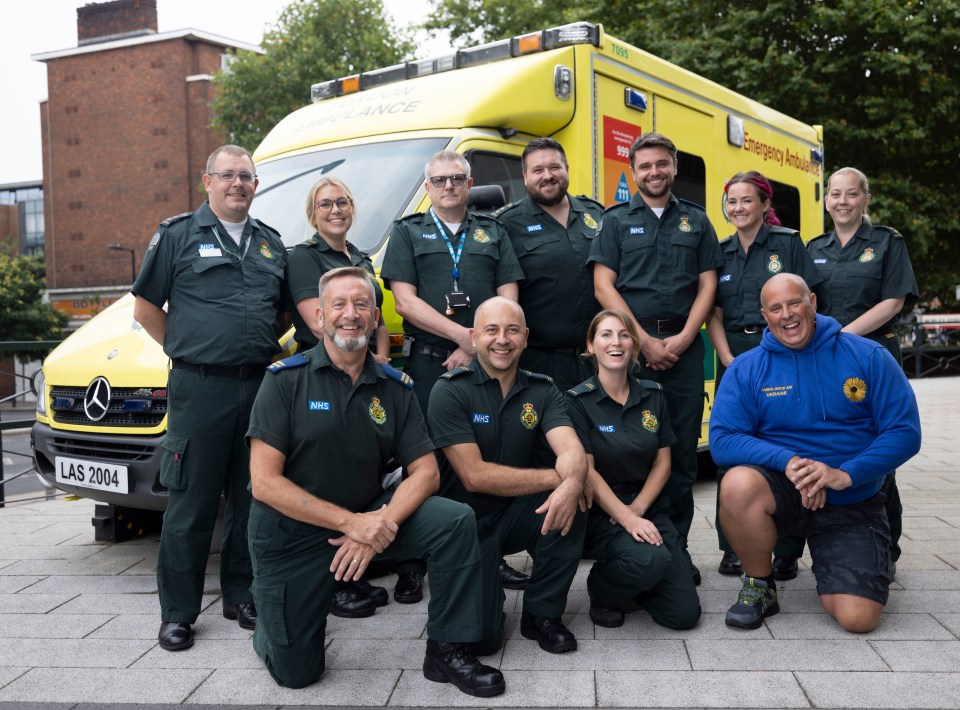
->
[807,221,919,331]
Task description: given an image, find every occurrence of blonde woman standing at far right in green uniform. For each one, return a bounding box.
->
[807,167,919,562]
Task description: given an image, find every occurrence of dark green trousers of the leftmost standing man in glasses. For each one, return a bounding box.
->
[157,369,263,624]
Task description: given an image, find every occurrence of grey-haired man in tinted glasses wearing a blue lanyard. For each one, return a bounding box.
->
[380,150,523,602]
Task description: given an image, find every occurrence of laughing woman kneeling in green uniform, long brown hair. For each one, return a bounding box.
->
[567,310,700,629]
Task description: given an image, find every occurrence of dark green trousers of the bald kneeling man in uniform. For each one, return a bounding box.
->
[477,492,587,646]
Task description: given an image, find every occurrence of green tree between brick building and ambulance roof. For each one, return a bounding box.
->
[213,0,413,150]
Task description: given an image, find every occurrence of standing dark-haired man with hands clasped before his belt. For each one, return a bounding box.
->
[588,132,723,584]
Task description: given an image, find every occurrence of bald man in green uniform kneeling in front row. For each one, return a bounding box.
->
[427,297,587,655]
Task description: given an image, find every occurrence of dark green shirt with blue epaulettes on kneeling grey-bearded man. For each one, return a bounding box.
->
[247,343,434,512]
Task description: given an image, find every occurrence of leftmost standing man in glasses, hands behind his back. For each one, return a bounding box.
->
[131,145,288,651]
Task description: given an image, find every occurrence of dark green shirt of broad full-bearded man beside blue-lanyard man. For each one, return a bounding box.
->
[494,195,603,350]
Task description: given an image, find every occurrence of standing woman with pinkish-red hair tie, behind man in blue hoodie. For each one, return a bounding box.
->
[707,170,823,581]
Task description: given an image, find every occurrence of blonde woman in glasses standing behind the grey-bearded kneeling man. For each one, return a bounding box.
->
[287,177,390,618]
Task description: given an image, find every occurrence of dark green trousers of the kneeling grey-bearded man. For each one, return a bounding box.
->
[249,490,481,688]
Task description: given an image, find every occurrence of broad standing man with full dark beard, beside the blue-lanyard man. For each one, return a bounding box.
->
[494,138,603,391]
